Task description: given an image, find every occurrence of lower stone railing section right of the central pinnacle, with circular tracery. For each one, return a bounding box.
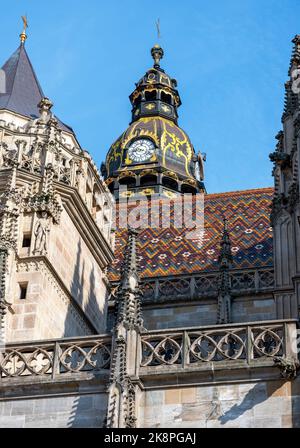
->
[141,320,297,371]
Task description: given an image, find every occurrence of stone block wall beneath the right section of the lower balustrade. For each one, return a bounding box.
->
[139,379,300,428]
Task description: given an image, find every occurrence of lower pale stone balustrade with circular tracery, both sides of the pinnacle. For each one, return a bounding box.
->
[0,320,298,383]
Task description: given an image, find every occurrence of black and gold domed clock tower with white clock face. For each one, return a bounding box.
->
[102,45,205,199]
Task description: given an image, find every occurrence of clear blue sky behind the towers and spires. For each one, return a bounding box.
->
[0,0,300,193]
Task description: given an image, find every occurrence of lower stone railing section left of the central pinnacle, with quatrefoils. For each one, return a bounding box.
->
[0,335,111,381]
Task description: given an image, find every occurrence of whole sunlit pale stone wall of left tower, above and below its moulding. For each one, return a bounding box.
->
[6,204,106,342]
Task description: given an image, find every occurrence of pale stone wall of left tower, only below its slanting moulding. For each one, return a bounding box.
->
[7,259,92,342]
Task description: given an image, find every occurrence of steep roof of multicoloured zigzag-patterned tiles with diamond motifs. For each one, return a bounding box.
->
[110,188,273,281]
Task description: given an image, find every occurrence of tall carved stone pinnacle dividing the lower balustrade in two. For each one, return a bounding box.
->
[106,229,143,428]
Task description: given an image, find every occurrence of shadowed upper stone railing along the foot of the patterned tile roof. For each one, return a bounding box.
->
[142,268,274,302]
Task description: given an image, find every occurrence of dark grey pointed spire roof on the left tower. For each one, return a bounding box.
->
[0,43,73,132]
